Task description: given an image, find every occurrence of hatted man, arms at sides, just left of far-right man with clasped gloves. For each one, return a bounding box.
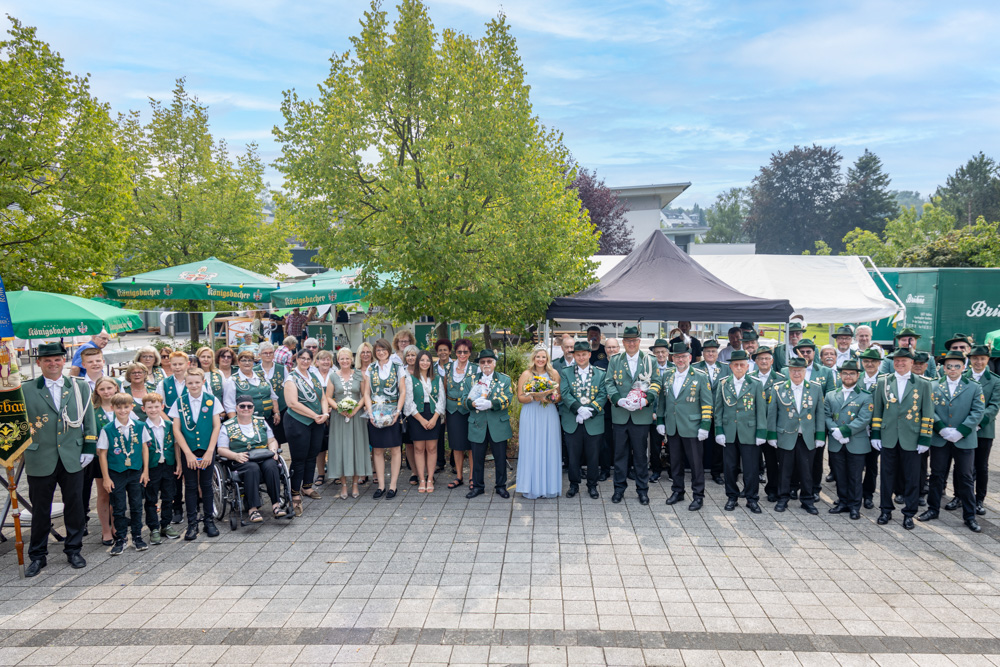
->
[871,347,934,530]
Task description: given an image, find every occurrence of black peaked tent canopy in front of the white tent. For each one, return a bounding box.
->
[546,231,792,322]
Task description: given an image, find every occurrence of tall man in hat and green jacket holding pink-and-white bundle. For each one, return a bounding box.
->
[604,327,660,505]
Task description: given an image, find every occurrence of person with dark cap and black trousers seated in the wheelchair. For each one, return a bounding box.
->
[218,394,285,523]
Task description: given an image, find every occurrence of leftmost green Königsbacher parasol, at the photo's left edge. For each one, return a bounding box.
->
[7,290,142,339]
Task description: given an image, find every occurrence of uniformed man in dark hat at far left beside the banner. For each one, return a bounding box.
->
[21,343,97,577]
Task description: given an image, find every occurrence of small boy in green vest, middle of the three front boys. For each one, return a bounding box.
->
[142,392,183,544]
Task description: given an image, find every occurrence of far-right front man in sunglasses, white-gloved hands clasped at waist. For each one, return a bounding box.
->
[917,350,986,533]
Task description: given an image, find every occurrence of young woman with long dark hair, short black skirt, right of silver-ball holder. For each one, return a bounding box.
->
[403,350,445,493]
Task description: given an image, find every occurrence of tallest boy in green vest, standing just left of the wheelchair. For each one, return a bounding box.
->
[167,368,223,541]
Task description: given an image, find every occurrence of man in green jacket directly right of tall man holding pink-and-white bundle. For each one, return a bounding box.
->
[656,343,716,512]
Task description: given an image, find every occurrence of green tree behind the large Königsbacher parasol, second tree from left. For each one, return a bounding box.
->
[119,79,294,342]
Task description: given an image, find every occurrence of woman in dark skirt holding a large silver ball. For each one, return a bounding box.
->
[361,338,406,500]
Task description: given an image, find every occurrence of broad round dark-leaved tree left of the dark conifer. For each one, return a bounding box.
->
[744,144,842,255]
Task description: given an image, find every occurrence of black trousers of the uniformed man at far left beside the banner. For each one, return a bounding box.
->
[28,459,87,560]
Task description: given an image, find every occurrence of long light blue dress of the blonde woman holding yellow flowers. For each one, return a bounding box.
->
[517,402,562,499]
